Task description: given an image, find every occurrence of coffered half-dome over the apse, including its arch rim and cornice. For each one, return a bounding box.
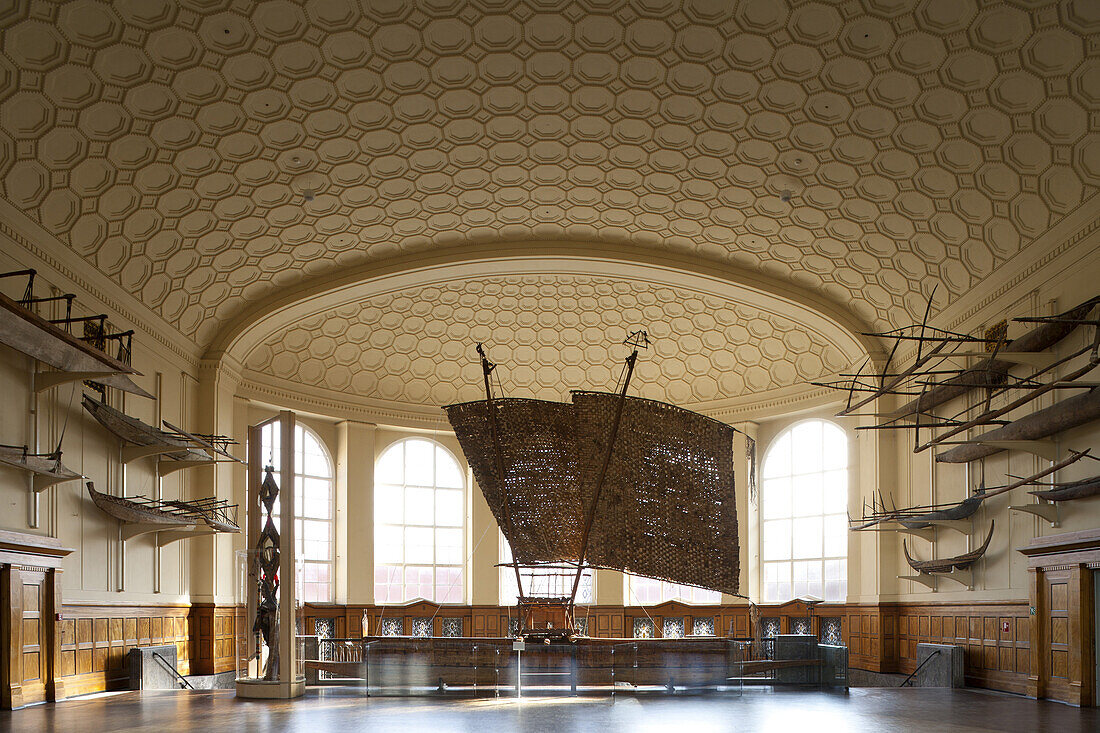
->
[225,242,875,419]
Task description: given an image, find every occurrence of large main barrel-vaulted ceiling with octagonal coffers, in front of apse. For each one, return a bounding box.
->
[0,0,1100,352]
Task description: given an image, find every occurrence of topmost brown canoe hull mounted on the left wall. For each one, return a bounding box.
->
[0,271,153,398]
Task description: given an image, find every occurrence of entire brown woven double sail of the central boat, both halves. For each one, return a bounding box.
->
[447,392,738,593]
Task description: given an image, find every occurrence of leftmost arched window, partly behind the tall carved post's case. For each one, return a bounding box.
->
[261,424,336,603]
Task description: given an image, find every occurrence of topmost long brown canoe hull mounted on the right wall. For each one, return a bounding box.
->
[894,298,1100,417]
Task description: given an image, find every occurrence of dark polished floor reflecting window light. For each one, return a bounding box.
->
[0,688,1100,733]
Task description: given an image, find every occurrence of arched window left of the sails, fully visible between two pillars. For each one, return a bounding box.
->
[374,438,466,603]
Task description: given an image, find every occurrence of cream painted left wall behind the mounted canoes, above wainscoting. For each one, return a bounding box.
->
[0,240,200,603]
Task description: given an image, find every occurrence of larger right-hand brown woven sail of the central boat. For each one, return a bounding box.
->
[573,392,738,593]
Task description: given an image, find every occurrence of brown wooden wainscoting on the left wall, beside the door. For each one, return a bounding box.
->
[58,604,193,696]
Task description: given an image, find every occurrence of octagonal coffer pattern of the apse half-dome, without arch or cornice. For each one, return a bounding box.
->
[244,275,850,406]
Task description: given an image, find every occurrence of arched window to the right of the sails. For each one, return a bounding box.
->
[760,420,848,601]
